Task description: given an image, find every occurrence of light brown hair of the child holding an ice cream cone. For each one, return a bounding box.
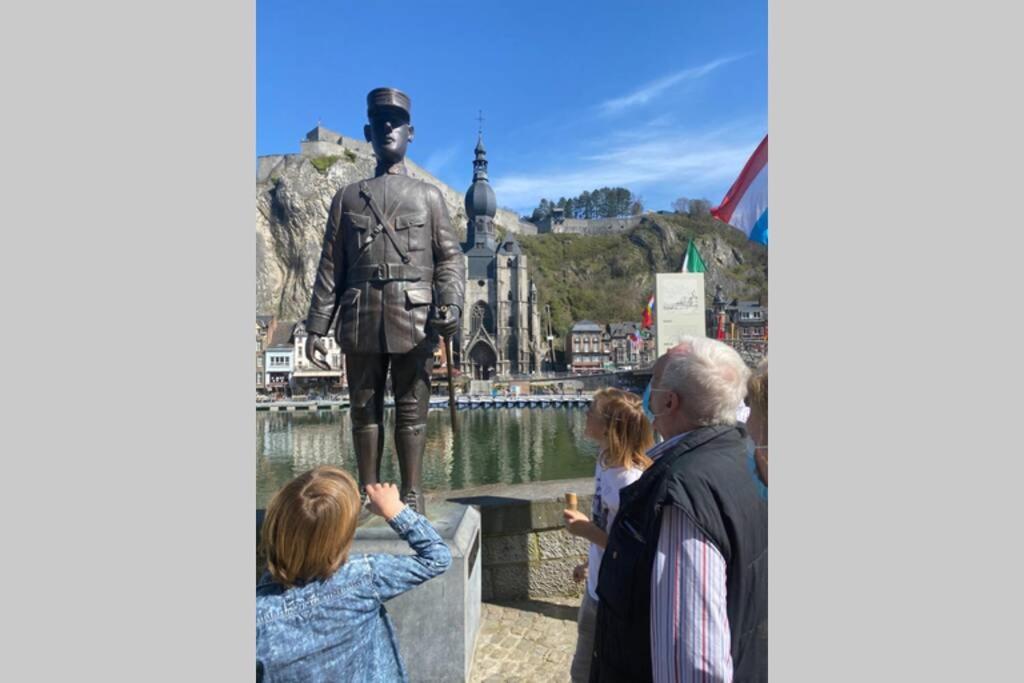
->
[594,387,654,470]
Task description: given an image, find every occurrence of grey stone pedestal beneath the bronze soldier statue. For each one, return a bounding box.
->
[351,500,482,681]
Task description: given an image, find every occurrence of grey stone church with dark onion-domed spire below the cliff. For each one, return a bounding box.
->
[454,131,544,380]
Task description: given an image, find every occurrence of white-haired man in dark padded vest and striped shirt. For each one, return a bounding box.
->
[591,337,768,682]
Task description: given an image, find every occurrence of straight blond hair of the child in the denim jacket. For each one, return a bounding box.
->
[260,465,359,588]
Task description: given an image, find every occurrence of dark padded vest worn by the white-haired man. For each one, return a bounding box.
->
[591,426,768,683]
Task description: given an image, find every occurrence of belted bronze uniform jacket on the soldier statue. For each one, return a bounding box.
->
[306,164,466,354]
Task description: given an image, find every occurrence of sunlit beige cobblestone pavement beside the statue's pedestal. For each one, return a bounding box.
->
[469,598,580,683]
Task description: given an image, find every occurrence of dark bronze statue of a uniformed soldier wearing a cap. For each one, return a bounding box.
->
[305,88,466,513]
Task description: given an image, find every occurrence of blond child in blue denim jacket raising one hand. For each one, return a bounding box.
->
[256,466,452,683]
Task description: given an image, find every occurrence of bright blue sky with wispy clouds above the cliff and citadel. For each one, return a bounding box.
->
[256,0,768,213]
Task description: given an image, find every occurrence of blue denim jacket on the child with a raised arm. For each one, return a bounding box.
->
[256,508,452,683]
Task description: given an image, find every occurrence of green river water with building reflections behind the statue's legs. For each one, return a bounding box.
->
[256,408,597,507]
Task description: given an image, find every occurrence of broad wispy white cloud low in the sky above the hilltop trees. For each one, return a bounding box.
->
[494,123,764,211]
